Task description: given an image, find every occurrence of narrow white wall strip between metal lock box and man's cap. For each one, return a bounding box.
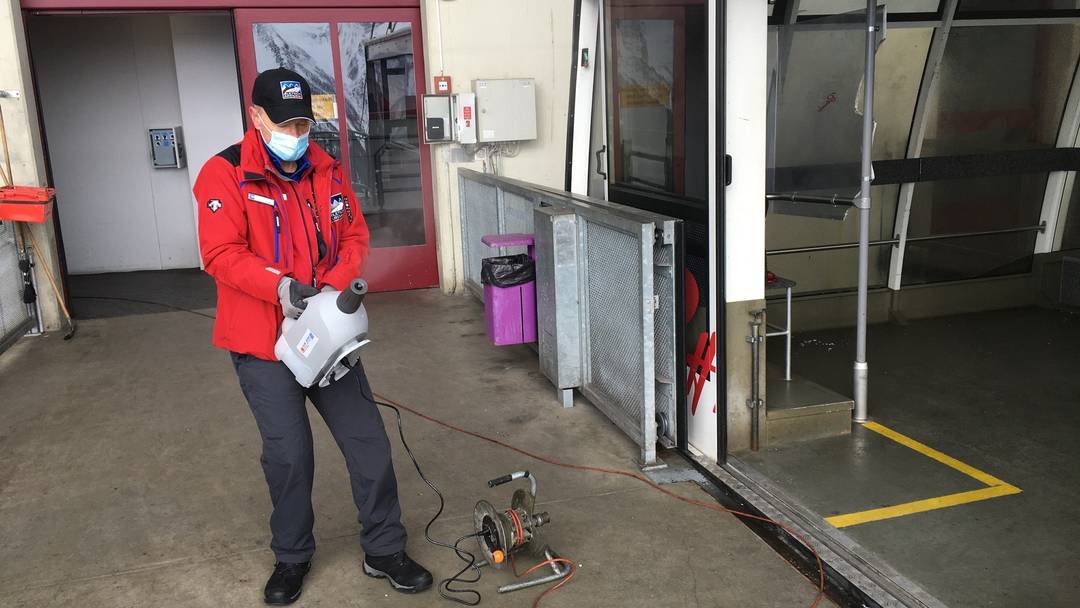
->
[170,13,244,265]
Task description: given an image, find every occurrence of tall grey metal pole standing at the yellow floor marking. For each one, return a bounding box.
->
[853,0,877,422]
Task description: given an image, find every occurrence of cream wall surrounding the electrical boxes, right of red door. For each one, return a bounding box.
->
[422,0,573,293]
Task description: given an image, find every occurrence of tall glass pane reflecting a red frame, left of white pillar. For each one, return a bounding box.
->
[606,2,708,201]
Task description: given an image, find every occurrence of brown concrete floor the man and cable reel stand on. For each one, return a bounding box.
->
[0,273,814,608]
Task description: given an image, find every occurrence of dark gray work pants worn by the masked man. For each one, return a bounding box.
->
[232,353,405,563]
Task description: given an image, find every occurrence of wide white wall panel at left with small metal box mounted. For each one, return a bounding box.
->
[31,15,199,273]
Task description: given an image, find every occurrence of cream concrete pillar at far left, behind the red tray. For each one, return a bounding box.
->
[0,0,63,330]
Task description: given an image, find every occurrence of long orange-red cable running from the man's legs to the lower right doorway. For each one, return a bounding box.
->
[375,393,825,608]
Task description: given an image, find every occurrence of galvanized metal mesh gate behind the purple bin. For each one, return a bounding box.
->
[459,170,679,464]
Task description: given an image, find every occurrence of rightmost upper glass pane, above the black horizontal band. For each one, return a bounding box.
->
[922,24,1080,157]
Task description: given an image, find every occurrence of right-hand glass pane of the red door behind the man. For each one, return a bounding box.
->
[338,23,426,247]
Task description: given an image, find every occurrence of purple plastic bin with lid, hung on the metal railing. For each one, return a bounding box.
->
[481,234,537,347]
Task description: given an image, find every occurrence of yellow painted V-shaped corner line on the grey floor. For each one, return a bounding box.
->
[825,422,1021,528]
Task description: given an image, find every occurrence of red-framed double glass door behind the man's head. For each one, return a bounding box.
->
[235,9,438,291]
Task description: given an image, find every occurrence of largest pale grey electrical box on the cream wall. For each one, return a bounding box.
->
[473,78,537,143]
